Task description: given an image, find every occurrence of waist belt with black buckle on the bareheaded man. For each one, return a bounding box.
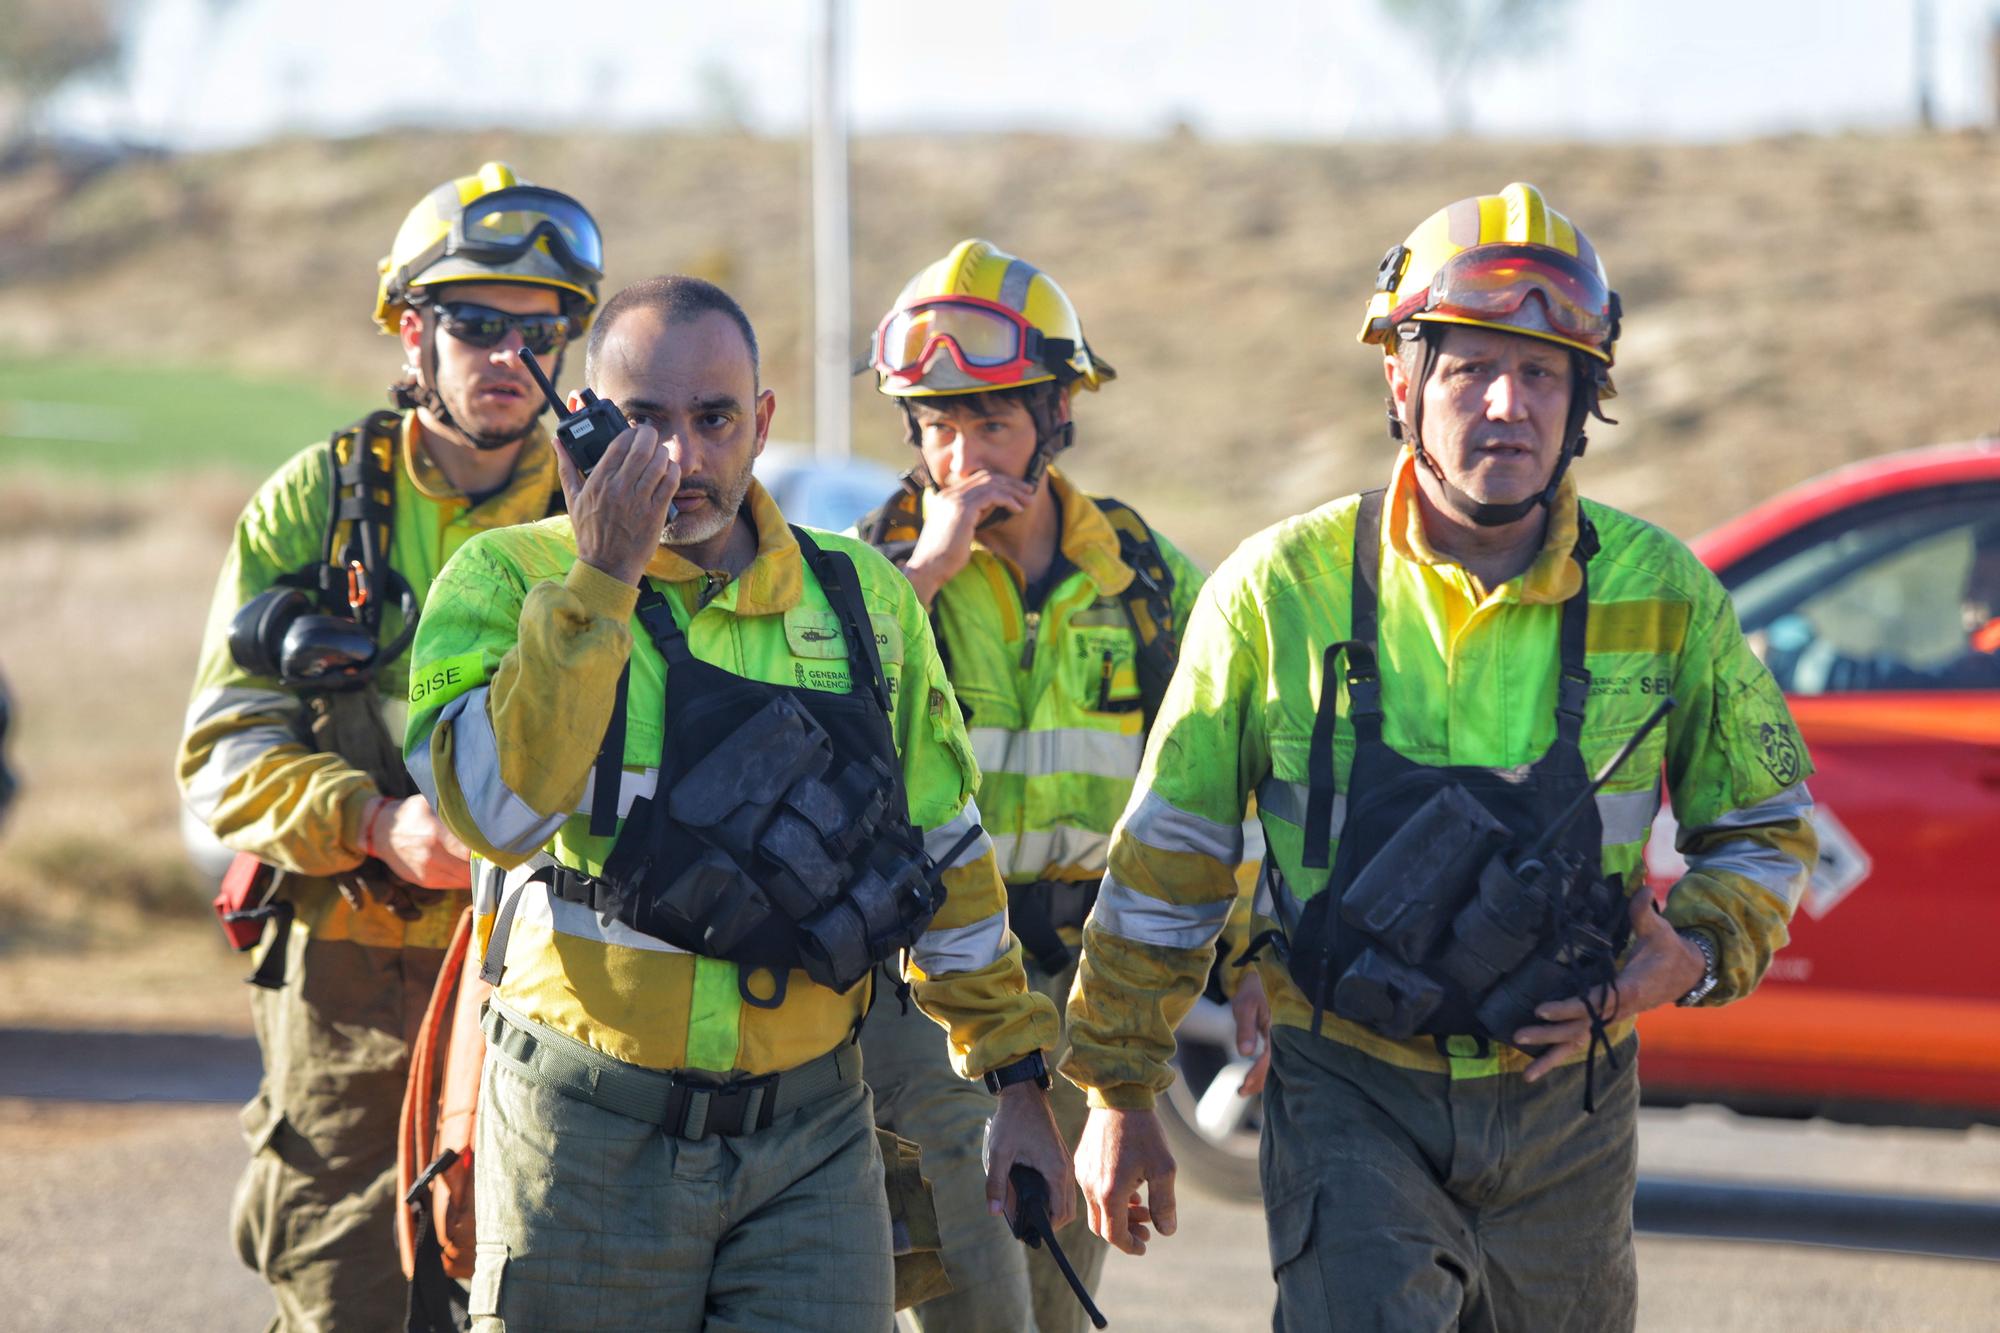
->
[480,1001,862,1139]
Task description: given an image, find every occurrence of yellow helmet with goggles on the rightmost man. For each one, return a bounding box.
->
[1360,182,1620,384]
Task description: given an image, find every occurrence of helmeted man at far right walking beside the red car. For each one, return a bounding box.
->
[1062,184,1814,1331]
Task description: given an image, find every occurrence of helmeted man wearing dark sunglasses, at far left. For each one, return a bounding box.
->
[178,162,604,1329]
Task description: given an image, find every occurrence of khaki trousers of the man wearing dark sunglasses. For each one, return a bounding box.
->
[230,912,444,1333]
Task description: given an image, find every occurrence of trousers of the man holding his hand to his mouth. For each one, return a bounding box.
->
[862,959,1110,1333]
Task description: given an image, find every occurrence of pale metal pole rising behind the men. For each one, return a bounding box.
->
[812,0,852,464]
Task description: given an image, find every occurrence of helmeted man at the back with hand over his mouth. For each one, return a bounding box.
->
[862,240,1262,1333]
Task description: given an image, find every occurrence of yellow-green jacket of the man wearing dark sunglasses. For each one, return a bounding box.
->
[176,412,556,949]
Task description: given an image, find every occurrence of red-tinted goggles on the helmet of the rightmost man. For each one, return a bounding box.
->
[1390,244,1618,356]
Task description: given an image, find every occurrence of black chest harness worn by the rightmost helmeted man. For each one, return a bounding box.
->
[1266,490,1644,1096]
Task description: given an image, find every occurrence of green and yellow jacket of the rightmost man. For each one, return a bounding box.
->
[1064,450,1816,1107]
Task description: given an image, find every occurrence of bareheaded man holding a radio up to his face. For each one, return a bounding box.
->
[396,276,1074,1333]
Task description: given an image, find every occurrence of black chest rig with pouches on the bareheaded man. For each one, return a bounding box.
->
[482,528,980,1009]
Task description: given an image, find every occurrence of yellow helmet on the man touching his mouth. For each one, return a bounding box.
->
[868,240,1118,398]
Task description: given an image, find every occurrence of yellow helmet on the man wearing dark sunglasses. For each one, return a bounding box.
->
[374,162,604,332]
